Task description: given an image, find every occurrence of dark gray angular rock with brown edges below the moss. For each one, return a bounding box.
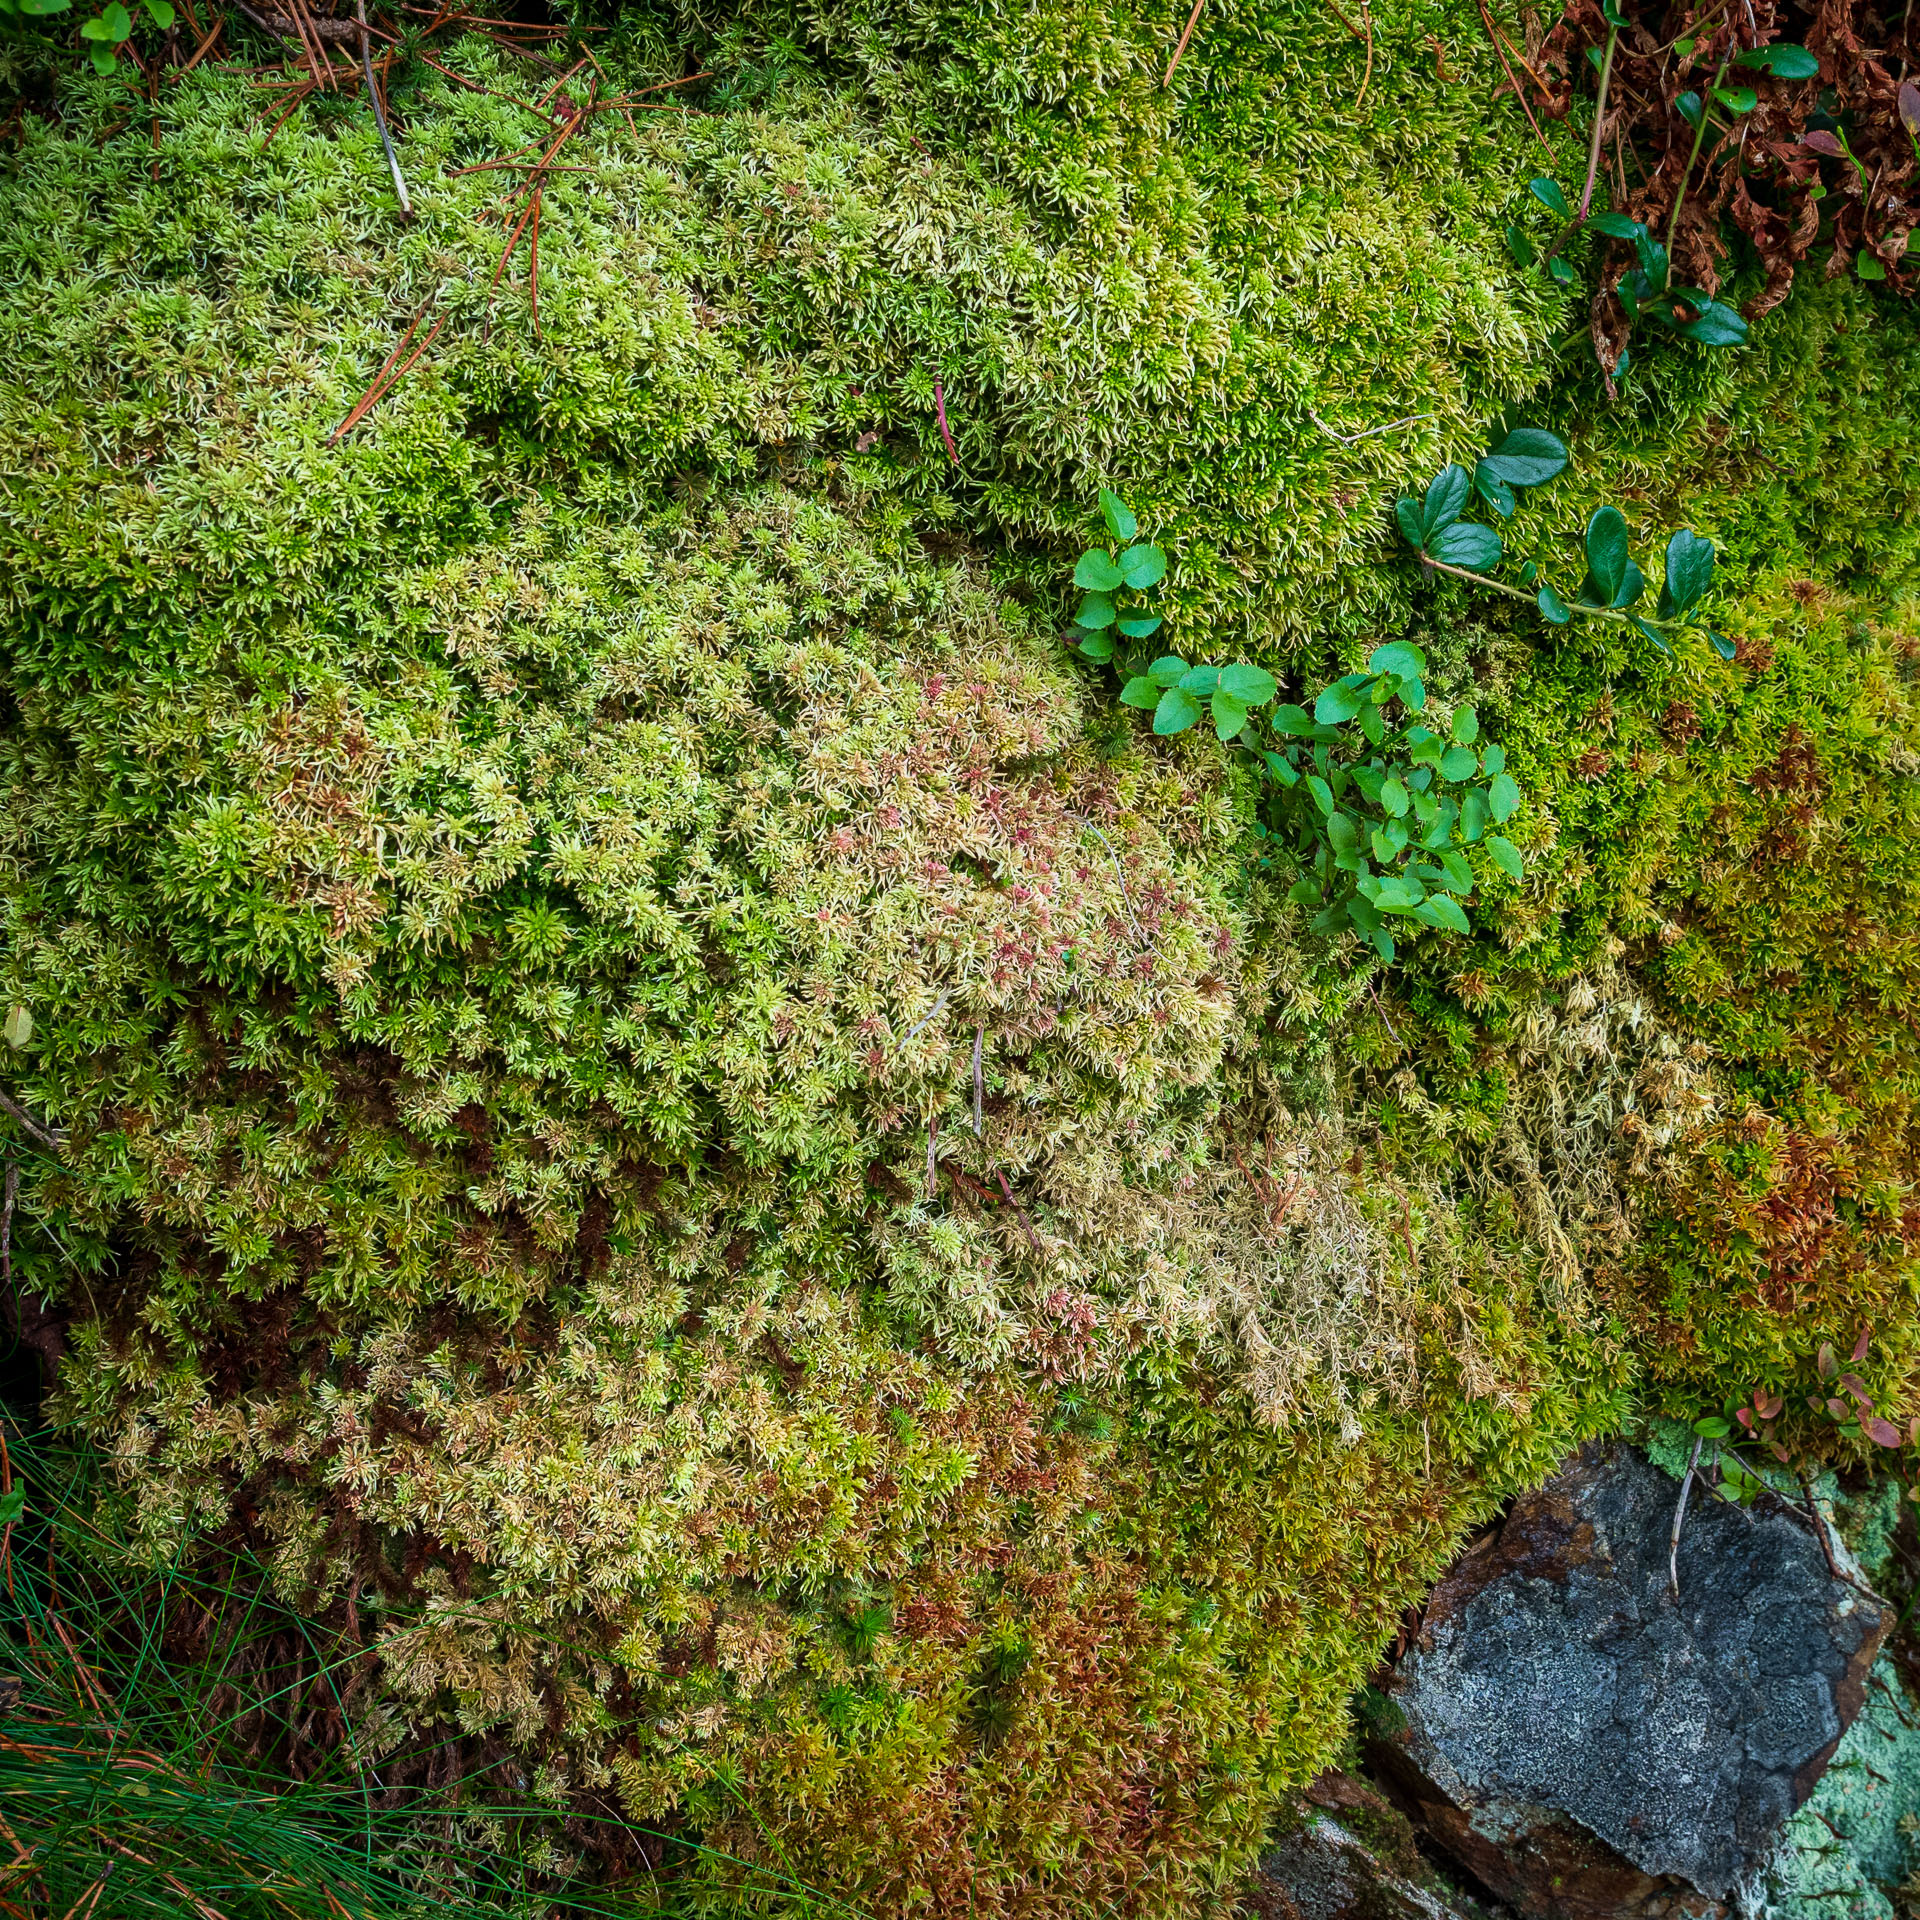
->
[1373,1446,1891,1920]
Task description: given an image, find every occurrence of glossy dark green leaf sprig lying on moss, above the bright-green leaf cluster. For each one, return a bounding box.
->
[1394,426,1736,660]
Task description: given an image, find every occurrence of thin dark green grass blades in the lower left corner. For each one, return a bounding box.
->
[0,1432,860,1920]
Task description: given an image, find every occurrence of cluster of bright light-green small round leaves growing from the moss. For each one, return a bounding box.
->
[1073,503,1528,960]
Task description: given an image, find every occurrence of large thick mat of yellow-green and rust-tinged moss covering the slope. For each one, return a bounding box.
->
[0,0,1920,1920]
